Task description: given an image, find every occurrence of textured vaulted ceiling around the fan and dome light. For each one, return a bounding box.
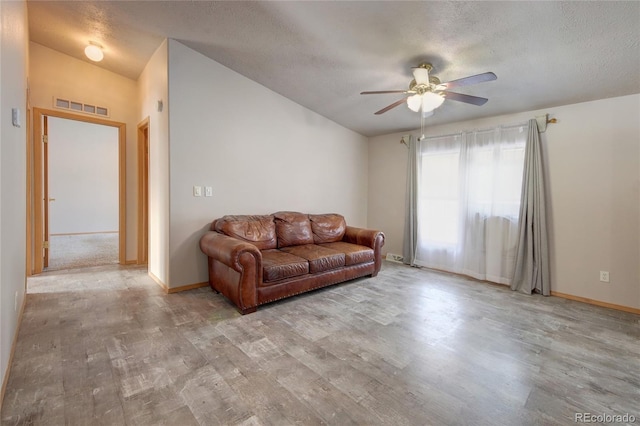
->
[28,1,640,136]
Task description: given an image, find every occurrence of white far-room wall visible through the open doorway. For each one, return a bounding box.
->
[47,117,119,234]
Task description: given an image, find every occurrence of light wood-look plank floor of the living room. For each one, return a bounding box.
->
[1,262,640,426]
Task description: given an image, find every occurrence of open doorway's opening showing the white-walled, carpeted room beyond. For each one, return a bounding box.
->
[44,116,118,271]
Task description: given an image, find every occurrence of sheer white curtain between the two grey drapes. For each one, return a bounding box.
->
[414,125,527,284]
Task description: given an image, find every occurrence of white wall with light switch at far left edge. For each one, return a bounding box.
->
[0,1,28,400]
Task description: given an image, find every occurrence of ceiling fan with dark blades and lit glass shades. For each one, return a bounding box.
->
[360,63,498,117]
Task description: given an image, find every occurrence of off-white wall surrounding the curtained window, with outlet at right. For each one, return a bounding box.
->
[369,95,640,308]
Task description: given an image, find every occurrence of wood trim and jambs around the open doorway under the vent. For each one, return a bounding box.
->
[27,108,126,275]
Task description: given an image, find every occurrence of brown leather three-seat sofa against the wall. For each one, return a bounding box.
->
[200,212,384,314]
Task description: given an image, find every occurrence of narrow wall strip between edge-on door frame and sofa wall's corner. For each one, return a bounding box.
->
[138,40,169,283]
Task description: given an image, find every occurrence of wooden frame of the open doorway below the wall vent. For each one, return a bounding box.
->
[27,108,127,275]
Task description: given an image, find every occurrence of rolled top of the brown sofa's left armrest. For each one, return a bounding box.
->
[200,231,262,272]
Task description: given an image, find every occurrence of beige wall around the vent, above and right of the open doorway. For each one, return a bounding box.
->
[29,42,139,260]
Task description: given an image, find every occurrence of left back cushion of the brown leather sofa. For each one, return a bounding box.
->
[212,215,278,250]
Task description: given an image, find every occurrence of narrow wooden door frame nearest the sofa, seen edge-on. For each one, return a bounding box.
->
[138,117,150,265]
